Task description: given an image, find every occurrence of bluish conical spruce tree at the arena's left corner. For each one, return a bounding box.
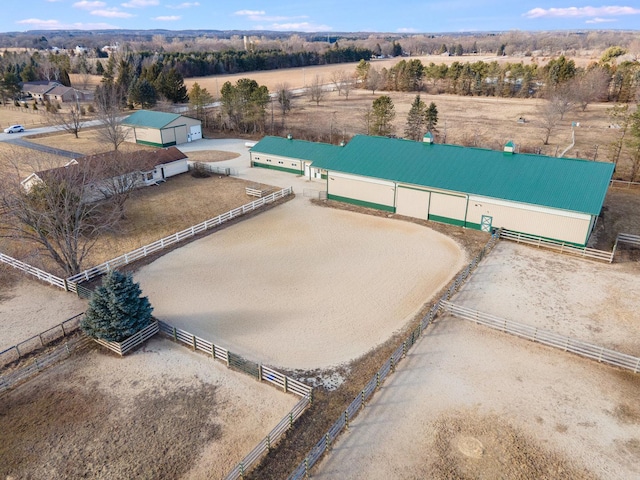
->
[80,271,153,342]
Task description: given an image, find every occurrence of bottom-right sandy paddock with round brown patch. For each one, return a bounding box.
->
[312,316,640,480]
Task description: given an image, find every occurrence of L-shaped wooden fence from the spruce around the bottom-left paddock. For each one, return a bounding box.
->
[158,321,313,480]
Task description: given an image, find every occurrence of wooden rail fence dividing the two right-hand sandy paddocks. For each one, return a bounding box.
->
[441,302,640,373]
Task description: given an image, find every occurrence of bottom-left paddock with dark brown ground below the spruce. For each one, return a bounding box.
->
[0,337,298,480]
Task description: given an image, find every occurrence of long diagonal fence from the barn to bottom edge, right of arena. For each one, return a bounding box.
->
[288,231,500,480]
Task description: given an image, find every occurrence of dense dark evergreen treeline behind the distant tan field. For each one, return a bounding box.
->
[136,47,373,77]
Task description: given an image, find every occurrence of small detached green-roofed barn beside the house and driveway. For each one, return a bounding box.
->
[122,110,202,148]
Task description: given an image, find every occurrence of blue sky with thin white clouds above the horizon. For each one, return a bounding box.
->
[0,0,640,33]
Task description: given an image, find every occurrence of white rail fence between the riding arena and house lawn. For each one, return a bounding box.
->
[67,187,293,286]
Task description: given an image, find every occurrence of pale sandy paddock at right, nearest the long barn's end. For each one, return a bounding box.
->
[452,241,640,357]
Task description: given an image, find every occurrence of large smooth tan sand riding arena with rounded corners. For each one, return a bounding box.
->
[135,197,466,369]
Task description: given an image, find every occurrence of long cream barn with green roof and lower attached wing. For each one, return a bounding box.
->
[251,135,614,246]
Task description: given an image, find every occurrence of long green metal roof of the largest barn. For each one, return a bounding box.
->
[310,135,614,215]
